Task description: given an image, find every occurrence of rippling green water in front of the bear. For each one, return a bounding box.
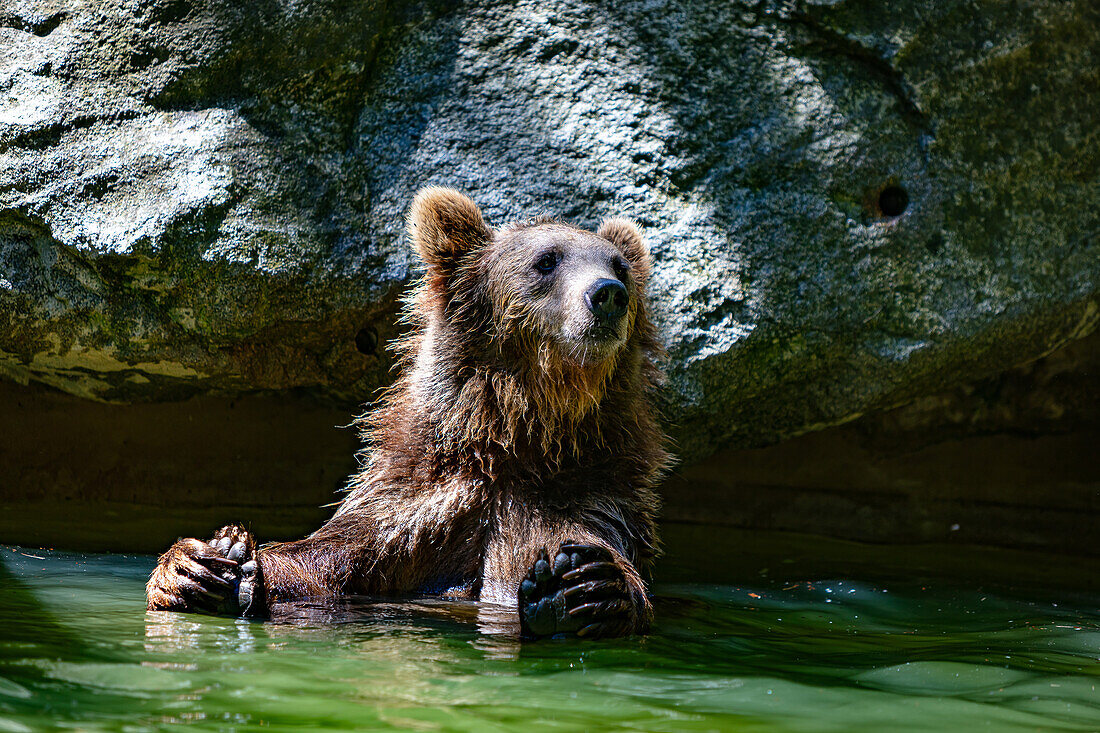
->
[0,528,1100,731]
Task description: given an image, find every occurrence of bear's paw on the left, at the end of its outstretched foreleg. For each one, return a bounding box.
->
[145,525,267,616]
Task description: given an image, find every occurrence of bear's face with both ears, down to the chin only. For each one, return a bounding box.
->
[409,188,650,368]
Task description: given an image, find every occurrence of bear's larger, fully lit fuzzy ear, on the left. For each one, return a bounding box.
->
[407,186,493,277]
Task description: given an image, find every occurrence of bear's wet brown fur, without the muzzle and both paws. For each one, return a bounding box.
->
[150,188,668,631]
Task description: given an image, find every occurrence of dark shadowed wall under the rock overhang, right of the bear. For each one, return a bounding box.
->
[661,331,1100,548]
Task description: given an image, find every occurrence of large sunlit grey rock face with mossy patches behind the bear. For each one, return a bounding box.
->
[0,0,1100,459]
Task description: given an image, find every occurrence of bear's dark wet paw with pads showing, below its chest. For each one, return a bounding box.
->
[518,541,652,638]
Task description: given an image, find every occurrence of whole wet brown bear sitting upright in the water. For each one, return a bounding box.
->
[147,188,669,637]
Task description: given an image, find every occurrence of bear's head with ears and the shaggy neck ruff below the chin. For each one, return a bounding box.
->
[406,183,659,451]
